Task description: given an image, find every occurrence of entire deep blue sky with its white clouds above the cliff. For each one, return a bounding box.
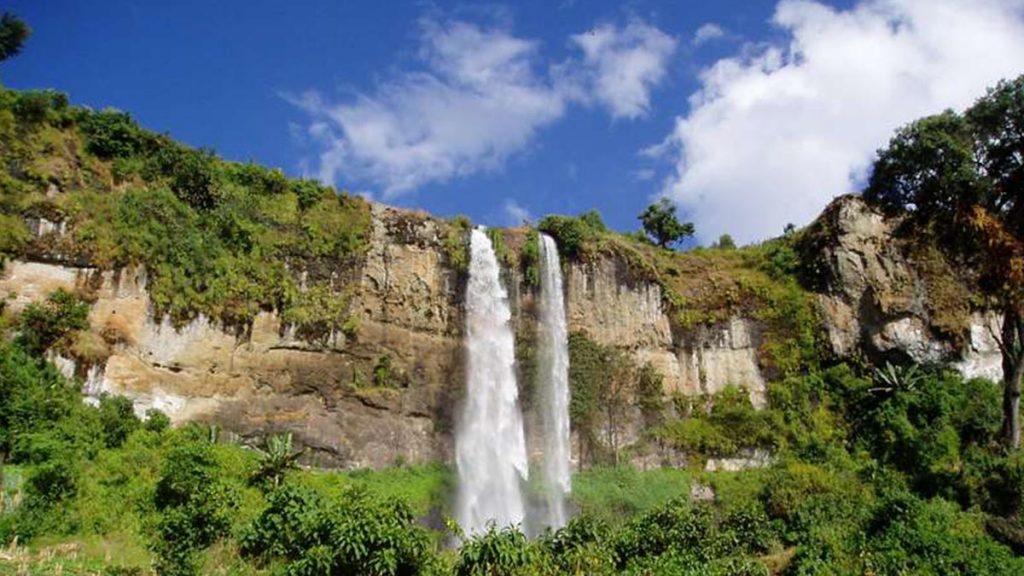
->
[0,0,1024,242]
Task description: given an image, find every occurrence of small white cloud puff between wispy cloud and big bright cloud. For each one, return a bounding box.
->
[571,20,677,118]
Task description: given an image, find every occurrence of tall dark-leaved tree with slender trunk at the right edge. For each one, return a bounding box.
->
[864,76,1024,449]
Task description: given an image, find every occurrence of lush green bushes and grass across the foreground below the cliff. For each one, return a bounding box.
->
[0,330,1024,575]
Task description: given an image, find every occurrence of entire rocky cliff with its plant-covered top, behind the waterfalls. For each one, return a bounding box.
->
[0,90,1001,467]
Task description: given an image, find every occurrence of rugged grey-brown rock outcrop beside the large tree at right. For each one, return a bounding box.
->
[804,196,1002,380]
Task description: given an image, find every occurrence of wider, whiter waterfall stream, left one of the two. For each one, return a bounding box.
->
[455,225,528,535]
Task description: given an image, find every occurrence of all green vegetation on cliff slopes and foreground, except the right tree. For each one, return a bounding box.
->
[0,72,1024,575]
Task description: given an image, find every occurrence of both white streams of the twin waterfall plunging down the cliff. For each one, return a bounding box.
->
[456,230,571,536]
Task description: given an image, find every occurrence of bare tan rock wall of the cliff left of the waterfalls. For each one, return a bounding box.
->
[0,206,462,467]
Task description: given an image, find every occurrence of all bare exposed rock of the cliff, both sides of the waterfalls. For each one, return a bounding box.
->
[0,197,1001,467]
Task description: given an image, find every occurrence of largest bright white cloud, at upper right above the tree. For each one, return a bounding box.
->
[648,0,1024,243]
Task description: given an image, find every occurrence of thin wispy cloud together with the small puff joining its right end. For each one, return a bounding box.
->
[286,19,675,200]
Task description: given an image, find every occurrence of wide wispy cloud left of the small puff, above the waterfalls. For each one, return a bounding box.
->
[292,22,565,198]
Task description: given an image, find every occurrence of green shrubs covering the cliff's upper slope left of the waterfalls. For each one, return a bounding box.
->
[0,85,370,339]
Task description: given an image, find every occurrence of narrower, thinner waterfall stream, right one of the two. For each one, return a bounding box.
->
[538,234,572,529]
